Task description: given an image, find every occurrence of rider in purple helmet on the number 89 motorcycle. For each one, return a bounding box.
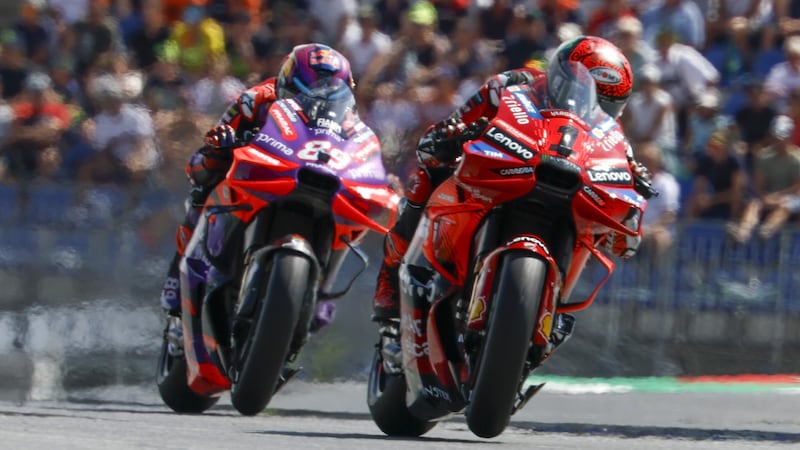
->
[161,43,355,331]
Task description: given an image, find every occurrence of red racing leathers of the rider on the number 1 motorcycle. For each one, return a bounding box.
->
[373,68,649,322]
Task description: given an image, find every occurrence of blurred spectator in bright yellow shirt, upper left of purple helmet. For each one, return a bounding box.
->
[170,0,225,78]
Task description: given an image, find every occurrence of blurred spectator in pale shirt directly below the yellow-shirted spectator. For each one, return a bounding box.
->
[189,55,245,116]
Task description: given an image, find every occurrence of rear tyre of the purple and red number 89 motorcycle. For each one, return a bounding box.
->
[156,317,219,414]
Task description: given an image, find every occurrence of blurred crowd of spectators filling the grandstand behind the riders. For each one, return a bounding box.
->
[0,0,800,253]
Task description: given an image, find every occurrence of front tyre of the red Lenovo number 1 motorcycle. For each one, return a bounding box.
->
[466,253,547,438]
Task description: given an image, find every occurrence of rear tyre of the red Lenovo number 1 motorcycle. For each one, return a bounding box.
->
[367,349,436,437]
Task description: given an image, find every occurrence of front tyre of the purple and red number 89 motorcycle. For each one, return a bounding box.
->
[231,253,313,416]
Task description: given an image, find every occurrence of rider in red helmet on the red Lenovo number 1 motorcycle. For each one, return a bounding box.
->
[373,36,651,324]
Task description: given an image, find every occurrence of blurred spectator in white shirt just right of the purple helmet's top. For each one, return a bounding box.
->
[340,4,392,79]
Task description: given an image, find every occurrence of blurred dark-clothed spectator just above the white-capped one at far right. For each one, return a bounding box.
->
[733,79,777,174]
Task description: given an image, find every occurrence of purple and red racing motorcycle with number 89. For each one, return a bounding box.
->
[156,79,398,415]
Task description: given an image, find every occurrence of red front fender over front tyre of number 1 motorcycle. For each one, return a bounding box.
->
[467,234,561,346]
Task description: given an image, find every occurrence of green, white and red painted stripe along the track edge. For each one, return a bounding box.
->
[528,374,800,394]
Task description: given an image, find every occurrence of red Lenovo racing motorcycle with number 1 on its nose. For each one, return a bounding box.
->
[368,61,654,438]
